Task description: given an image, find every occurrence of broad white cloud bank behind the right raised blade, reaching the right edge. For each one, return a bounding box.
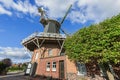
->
[35,0,120,24]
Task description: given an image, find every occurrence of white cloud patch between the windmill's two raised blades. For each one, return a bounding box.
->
[35,0,76,18]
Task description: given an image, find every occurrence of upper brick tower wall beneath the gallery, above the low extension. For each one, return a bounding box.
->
[31,44,60,74]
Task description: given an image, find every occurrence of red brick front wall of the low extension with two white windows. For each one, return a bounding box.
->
[36,56,66,78]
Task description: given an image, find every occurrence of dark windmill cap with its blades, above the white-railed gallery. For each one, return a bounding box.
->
[38,5,72,36]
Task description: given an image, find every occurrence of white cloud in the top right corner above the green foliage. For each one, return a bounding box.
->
[77,0,120,22]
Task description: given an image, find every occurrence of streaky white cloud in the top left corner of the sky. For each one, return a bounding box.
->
[0,0,37,17]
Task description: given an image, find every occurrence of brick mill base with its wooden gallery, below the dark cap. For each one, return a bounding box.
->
[21,33,82,78]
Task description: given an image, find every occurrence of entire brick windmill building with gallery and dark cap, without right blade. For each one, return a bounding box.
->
[22,9,86,80]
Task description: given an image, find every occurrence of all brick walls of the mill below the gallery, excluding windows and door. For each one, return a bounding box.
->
[32,44,77,78]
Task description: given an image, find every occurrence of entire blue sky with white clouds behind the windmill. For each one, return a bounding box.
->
[0,0,120,63]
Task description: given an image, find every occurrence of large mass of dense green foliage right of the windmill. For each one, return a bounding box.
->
[64,14,120,63]
